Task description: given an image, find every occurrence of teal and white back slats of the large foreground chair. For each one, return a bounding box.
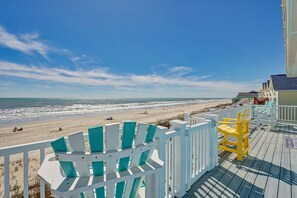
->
[51,121,157,198]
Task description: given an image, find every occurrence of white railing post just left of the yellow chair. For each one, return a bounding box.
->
[205,114,219,170]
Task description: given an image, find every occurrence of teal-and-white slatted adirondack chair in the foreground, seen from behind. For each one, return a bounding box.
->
[38,121,165,198]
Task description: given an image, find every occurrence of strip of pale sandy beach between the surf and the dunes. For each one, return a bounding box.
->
[0,99,230,148]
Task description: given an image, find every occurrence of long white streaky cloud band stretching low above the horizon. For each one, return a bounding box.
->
[0,61,258,94]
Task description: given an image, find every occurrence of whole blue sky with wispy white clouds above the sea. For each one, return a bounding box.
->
[0,0,285,98]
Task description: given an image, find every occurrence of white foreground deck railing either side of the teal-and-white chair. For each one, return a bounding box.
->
[0,118,218,198]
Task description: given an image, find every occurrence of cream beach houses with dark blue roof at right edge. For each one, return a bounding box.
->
[259,74,297,105]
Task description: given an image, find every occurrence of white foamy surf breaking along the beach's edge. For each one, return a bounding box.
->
[0,99,224,124]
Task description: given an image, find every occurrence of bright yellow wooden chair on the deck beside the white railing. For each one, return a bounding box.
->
[218,109,250,161]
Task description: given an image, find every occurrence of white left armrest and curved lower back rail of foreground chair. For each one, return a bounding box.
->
[38,154,164,196]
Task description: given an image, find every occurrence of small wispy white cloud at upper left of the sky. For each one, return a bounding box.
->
[0,26,50,58]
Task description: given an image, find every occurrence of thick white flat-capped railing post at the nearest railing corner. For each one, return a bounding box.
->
[170,120,190,197]
